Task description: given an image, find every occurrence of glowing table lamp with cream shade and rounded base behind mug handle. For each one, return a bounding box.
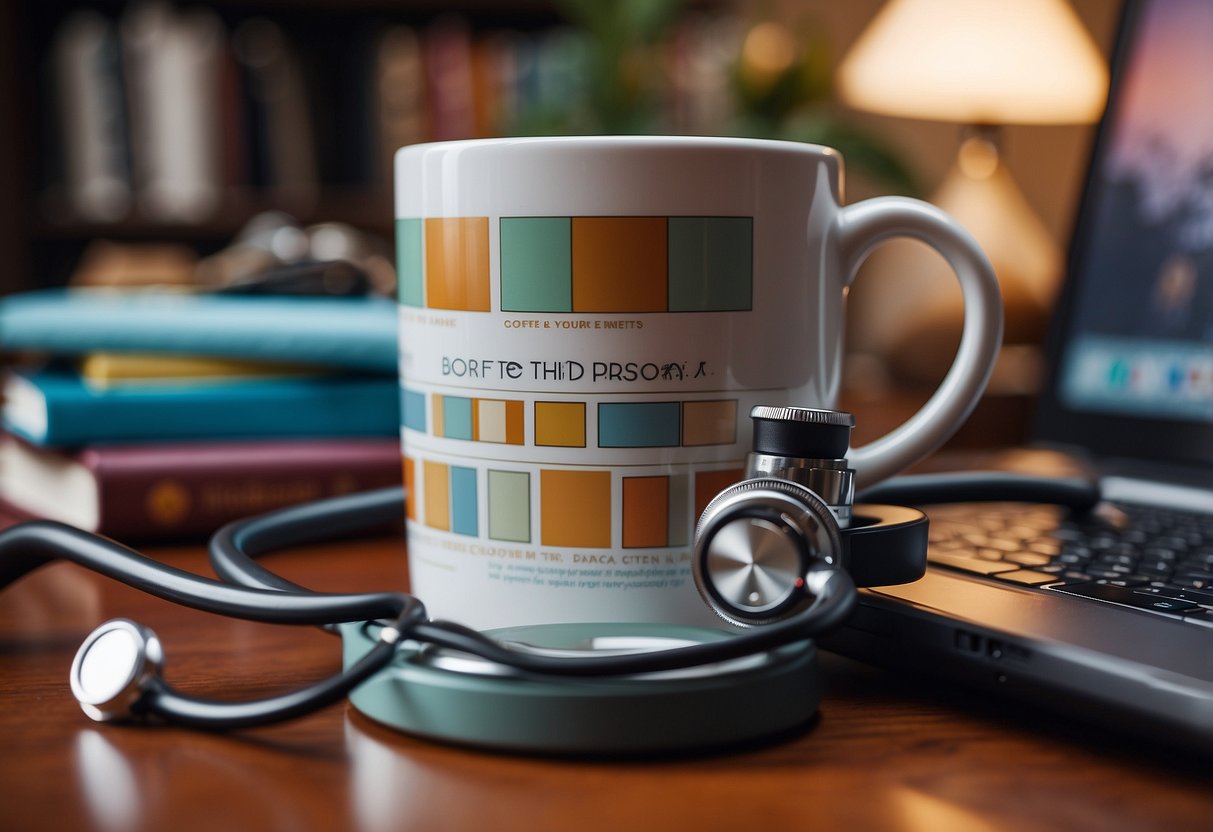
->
[836,0,1107,389]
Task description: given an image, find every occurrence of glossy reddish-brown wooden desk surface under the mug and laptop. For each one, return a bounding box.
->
[0,538,1213,832]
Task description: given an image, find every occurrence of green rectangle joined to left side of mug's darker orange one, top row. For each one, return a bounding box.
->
[500,217,573,312]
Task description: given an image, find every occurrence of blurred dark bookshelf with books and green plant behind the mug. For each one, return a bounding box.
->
[0,0,915,299]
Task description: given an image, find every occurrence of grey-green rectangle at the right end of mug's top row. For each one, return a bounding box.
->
[668,217,753,312]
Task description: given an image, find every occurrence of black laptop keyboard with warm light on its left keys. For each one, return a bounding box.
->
[928,503,1213,627]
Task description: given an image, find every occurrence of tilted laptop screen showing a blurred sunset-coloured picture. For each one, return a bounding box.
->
[1038,0,1213,470]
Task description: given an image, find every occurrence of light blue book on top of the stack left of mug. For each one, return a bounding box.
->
[0,289,398,374]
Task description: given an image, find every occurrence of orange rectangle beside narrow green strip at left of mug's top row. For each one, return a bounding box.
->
[426,217,490,312]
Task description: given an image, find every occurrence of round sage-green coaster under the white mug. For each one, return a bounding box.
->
[341,622,821,754]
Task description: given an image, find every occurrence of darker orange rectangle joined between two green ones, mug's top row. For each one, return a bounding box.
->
[573,217,670,312]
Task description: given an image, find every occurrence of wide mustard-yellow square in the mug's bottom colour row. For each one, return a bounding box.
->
[539,469,610,549]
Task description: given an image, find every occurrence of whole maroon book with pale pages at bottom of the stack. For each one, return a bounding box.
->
[0,434,403,541]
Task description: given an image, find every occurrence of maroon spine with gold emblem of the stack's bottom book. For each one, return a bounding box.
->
[86,452,403,541]
